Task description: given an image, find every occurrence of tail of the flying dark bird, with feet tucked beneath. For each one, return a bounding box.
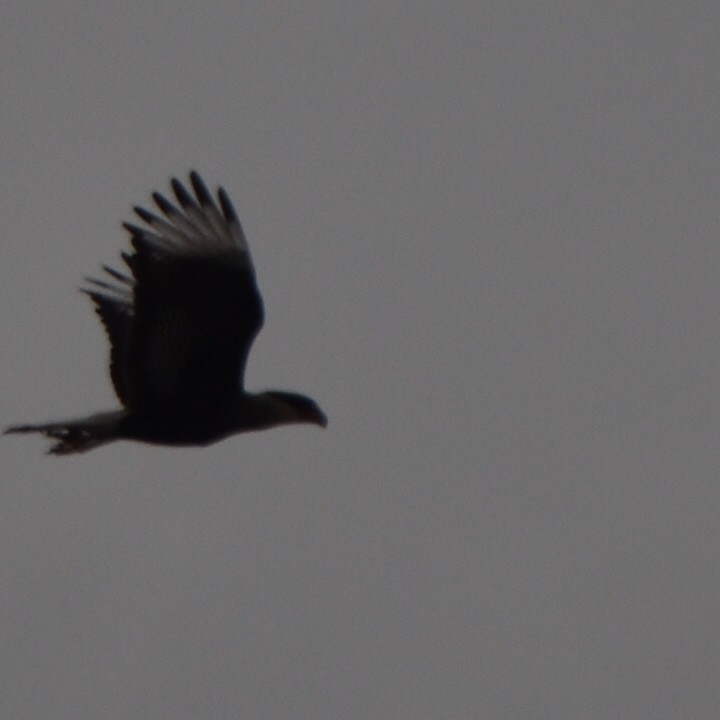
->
[4,410,126,455]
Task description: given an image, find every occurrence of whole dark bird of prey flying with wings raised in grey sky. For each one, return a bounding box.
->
[5,171,327,455]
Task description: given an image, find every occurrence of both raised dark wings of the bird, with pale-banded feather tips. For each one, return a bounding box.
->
[86,172,263,412]
